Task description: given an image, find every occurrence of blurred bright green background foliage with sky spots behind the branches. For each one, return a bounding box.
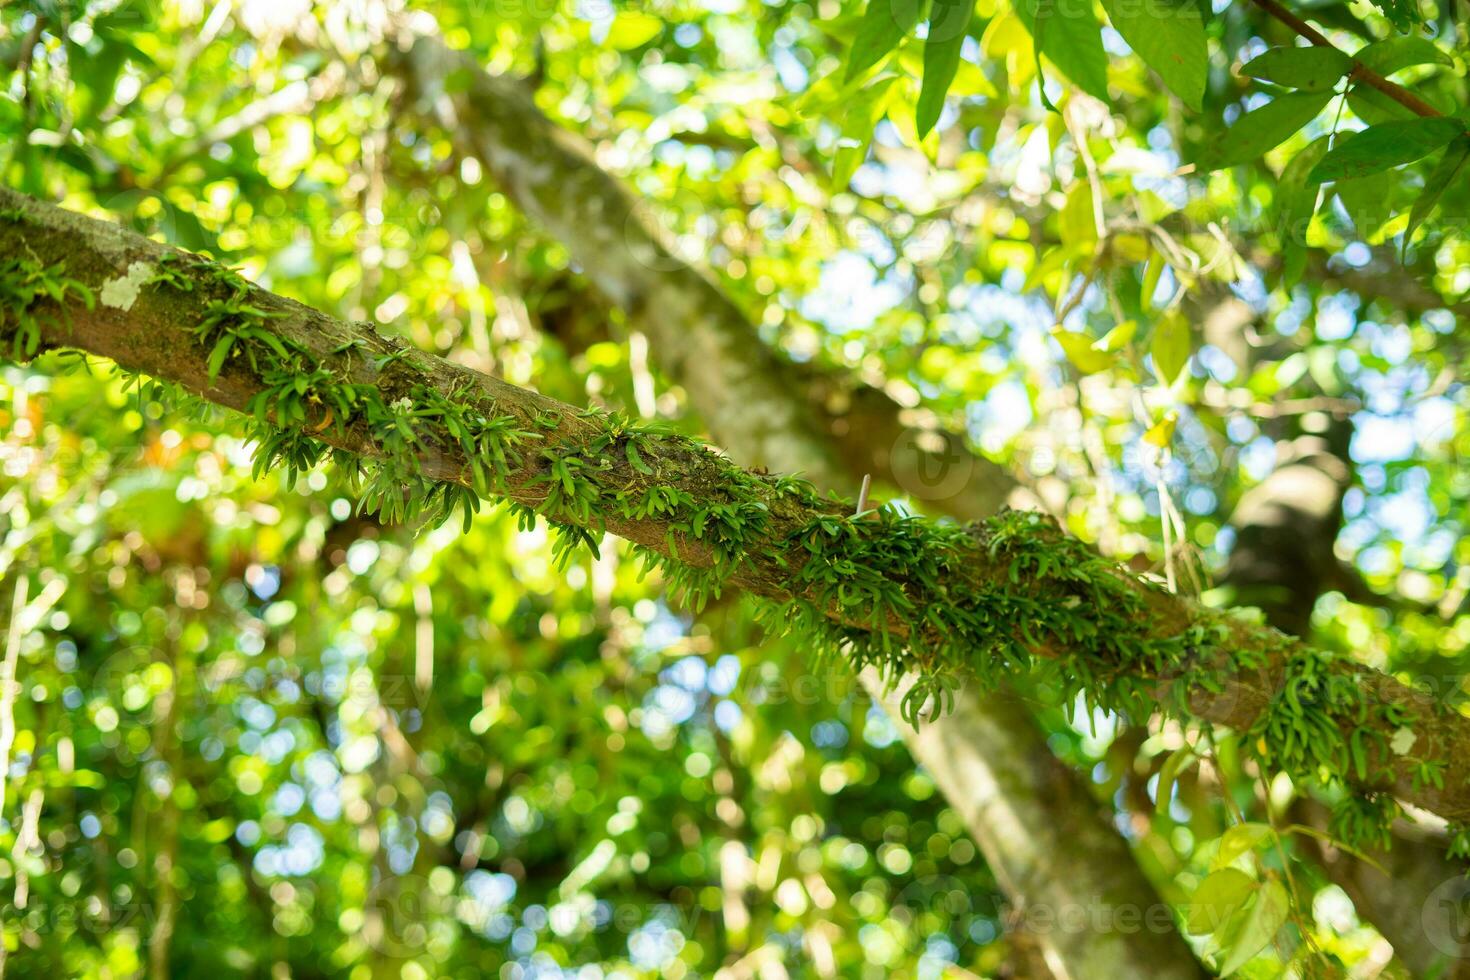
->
[0,0,1470,979]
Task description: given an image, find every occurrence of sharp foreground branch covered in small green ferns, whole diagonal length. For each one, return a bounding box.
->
[0,190,1470,835]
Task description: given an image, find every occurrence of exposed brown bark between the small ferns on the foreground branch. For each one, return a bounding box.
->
[0,188,1470,821]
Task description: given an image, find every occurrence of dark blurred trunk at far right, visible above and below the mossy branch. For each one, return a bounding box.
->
[1223,422,1470,980]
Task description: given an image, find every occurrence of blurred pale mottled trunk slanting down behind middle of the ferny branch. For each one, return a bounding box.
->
[382,22,1217,977]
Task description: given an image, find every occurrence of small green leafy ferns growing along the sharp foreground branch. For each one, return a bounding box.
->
[0,243,1446,843]
